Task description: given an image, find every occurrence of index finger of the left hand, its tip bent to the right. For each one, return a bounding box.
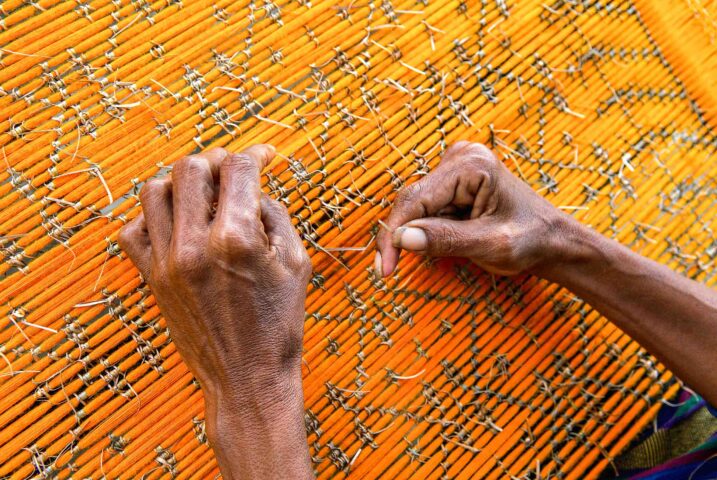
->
[217,145,275,229]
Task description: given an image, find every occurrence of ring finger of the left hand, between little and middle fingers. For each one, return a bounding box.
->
[139,177,173,258]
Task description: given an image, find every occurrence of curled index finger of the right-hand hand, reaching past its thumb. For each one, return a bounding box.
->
[376,168,457,276]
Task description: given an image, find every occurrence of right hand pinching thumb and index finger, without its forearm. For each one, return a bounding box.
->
[376,141,582,276]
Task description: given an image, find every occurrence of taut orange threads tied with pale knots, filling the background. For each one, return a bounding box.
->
[0,0,717,479]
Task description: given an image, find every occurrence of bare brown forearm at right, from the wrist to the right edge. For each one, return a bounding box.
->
[536,222,717,405]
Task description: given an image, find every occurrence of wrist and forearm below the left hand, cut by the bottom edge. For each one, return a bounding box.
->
[201,370,314,480]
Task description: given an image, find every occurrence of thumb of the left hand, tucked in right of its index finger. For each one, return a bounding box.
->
[261,195,307,264]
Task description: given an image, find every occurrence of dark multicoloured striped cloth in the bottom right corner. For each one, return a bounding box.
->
[603,390,717,480]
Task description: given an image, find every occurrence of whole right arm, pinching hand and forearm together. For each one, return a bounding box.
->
[376,142,717,405]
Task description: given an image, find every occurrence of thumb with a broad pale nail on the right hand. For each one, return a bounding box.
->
[392,217,490,257]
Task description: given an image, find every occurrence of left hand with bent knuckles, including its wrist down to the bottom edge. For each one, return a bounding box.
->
[119,145,311,478]
